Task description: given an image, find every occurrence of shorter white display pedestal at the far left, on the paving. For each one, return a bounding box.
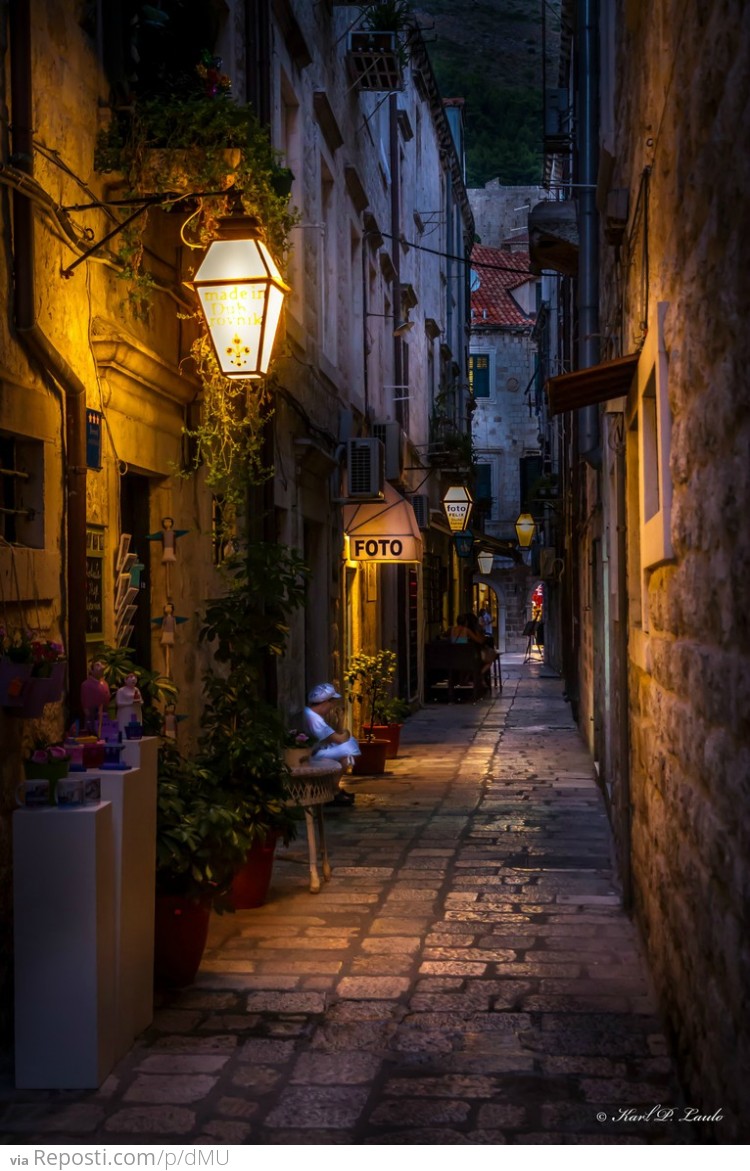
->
[13,803,115,1089]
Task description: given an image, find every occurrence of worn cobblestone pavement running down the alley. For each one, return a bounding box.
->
[0,656,701,1144]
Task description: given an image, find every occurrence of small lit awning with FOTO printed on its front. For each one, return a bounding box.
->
[343,484,422,562]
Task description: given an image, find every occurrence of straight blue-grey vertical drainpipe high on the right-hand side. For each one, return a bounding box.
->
[575,0,601,467]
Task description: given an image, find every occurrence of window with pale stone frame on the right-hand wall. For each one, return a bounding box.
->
[638,301,673,569]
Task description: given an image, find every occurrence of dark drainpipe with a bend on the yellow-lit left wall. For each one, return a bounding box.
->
[8,4,87,714]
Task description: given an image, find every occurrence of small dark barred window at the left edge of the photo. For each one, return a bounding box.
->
[0,433,45,549]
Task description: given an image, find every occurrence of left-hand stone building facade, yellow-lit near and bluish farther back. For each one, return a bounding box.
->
[0,0,473,1033]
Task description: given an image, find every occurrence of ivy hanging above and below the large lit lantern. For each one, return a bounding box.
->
[95,57,295,498]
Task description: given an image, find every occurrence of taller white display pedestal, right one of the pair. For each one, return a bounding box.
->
[101,738,157,1060]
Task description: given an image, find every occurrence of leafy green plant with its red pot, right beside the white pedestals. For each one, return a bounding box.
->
[155,740,250,987]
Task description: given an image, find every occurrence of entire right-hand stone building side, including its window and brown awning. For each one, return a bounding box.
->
[541,0,750,1143]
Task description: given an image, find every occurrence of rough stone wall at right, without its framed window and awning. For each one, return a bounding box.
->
[602,0,750,1143]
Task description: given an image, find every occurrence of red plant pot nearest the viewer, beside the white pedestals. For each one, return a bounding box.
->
[154,895,211,988]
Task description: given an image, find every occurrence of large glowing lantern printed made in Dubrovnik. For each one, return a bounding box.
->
[188,215,289,378]
